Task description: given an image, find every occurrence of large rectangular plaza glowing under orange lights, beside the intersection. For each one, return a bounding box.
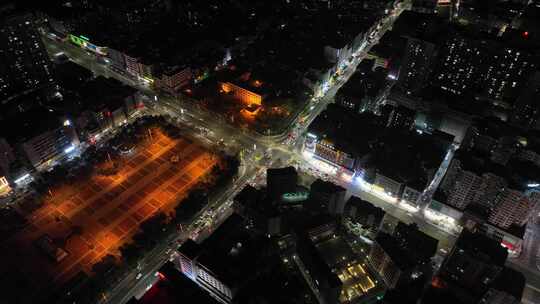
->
[3,129,218,288]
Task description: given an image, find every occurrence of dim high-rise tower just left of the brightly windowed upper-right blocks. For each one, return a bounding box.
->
[398,37,438,93]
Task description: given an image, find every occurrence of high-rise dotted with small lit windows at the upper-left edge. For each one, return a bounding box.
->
[0,8,53,103]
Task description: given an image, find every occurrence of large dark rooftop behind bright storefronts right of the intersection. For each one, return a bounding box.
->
[308,104,446,182]
